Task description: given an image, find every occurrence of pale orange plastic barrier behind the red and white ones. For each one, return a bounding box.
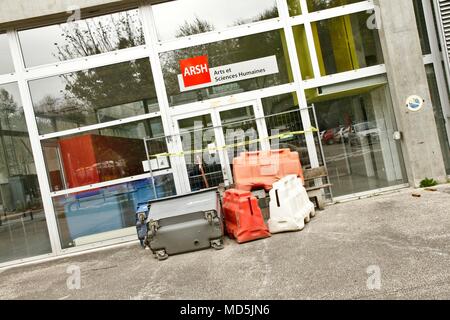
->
[233,149,304,191]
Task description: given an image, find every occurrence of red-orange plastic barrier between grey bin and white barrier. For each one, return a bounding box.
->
[223,189,270,243]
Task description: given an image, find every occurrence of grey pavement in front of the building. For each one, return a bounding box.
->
[0,185,450,300]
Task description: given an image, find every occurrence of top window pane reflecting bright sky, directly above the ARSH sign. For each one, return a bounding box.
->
[152,0,278,41]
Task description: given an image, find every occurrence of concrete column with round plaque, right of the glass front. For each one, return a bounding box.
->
[374,0,447,187]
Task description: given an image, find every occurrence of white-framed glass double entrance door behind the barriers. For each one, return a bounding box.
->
[178,102,265,191]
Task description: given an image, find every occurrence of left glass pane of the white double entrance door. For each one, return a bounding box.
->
[178,114,224,191]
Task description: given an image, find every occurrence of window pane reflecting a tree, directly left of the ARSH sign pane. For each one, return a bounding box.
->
[30,59,159,134]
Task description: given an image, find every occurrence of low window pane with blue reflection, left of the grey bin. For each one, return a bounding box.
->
[53,174,176,248]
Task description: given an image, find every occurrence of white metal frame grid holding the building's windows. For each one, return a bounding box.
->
[0,0,414,268]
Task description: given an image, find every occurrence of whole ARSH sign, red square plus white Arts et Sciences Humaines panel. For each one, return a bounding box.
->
[178,56,279,92]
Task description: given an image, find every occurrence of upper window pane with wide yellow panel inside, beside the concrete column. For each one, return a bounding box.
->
[312,12,384,76]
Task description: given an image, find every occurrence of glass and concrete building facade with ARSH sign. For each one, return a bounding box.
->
[0,0,450,267]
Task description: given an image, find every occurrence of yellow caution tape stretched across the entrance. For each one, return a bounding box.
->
[150,127,319,158]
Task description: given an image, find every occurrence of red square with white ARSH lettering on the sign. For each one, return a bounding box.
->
[180,56,211,88]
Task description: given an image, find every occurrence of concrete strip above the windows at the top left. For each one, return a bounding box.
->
[0,0,171,29]
